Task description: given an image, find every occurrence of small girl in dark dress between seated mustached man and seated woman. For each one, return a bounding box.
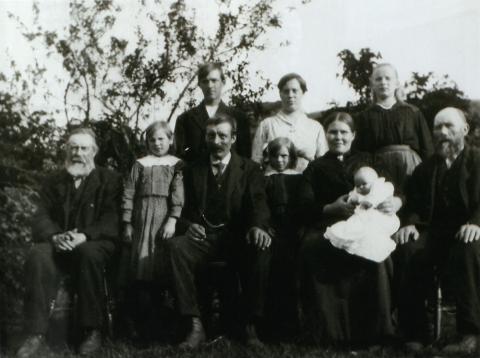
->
[265,137,302,339]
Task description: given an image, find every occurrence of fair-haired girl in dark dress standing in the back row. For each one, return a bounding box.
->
[354,63,433,192]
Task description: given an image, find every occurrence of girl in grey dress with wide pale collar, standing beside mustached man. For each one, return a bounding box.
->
[122,121,184,282]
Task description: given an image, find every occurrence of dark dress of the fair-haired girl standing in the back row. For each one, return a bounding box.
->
[353,102,433,189]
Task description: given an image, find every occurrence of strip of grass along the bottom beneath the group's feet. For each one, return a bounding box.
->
[0,298,464,358]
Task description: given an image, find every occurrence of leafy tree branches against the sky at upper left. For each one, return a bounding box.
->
[5,0,286,172]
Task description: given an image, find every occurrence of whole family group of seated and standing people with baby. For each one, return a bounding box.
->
[18,63,480,357]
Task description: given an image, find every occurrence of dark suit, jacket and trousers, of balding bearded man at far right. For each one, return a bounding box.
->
[395,146,480,340]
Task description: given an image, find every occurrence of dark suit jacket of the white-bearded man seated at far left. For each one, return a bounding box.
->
[32,168,122,241]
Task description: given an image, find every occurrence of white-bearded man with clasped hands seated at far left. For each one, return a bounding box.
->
[17,128,121,357]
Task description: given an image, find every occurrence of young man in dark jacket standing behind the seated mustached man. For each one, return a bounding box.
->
[175,62,251,162]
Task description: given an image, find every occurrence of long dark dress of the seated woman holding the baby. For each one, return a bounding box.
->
[299,152,393,344]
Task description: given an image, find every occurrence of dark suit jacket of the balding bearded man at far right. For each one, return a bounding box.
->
[406,146,480,227]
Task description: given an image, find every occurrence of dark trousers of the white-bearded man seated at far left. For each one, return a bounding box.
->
[25,240,115,334]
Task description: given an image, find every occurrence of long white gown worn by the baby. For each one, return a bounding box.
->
[324,178,400,262]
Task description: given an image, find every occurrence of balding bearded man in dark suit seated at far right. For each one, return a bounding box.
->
[395,107,480,354]
